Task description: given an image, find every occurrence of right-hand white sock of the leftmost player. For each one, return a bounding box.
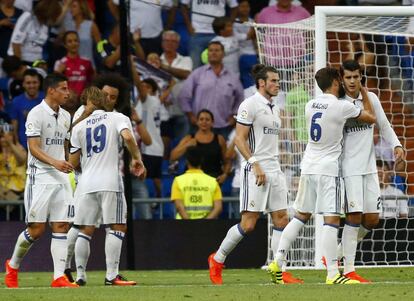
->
[50,233,68,279]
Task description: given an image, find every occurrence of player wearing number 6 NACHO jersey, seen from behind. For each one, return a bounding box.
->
[269,67,375,284]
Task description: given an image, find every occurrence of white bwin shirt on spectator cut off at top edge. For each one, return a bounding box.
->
[180,0,238,33]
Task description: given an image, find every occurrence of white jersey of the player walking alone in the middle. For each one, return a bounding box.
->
[237,92,282,172]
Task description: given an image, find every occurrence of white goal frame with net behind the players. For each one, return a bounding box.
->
[253,6,414,268]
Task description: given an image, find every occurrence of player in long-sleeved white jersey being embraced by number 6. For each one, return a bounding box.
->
[338,60,405,283]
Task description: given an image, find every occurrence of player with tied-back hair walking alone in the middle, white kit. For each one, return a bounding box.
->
[208,65,302,284]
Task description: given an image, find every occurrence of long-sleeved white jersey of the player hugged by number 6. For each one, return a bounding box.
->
[342,92,401,177]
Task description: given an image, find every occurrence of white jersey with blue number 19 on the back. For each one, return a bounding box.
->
[71,110,132,194]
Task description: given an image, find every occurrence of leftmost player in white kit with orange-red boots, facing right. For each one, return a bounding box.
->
[5,74,77,288]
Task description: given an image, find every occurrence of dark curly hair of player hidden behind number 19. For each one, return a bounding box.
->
[92,72,131,116]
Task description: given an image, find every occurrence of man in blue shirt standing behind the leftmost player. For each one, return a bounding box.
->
[11,69,45,149]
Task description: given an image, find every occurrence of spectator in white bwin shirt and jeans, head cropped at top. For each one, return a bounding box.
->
[181,0,238,68]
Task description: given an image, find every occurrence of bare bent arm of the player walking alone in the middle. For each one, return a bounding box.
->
[234,123,266,186]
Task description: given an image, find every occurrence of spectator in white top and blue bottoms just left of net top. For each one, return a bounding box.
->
[233,0,257,89]
